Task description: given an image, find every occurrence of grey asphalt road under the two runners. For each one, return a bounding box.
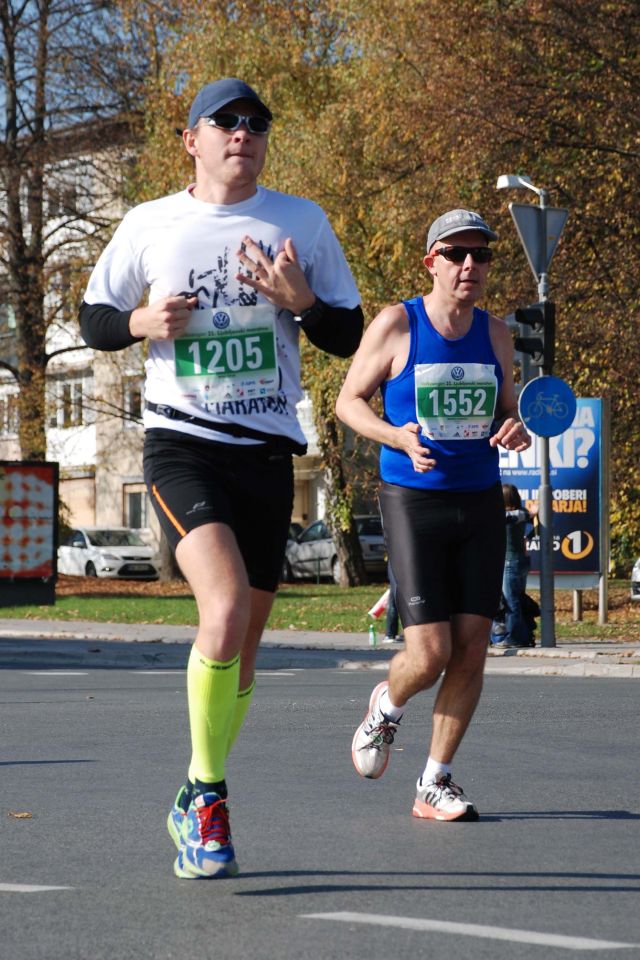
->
[0,667,640,960]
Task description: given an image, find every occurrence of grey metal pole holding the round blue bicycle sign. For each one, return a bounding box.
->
[538,190,556,647]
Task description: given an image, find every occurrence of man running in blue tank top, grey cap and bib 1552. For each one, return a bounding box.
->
[337,210,531,821]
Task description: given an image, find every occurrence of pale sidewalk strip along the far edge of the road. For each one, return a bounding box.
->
[0,619,640,679]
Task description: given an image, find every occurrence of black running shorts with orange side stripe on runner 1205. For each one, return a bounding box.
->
[144,429,293,592]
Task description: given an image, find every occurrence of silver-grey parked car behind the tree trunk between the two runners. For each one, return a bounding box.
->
[282,515,387,583]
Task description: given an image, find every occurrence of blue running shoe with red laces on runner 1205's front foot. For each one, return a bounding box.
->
[173,793,238,880]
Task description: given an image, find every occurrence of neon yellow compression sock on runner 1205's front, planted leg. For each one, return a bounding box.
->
[187,644,240,783]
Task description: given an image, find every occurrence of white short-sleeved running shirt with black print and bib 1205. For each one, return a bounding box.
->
[84,187,360,443]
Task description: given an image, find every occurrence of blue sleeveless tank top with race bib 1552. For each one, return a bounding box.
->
[380,297,504,491]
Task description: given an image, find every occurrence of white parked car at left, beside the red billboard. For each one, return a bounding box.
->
[58,527,160,580]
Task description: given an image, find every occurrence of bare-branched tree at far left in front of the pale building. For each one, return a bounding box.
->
[0,0,170,459]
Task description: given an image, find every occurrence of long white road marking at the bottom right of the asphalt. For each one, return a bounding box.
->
[300,911,640,950]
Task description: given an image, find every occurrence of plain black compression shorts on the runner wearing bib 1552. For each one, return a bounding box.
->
[380,483,505,627]
